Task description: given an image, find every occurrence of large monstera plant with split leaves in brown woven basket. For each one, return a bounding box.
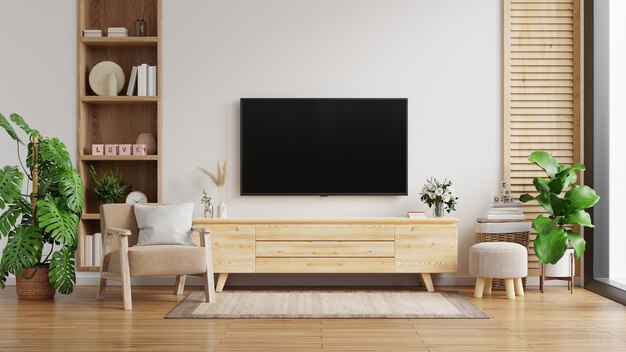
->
[0,114,84,298]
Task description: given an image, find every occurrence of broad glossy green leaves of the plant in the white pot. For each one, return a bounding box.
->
[520,151,600,264]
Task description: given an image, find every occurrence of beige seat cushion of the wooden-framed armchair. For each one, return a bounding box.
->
[109,245,207,277]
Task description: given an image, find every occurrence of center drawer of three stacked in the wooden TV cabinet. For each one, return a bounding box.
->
[256,241,394,257]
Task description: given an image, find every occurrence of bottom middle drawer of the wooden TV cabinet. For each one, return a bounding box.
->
[256,258,394,273]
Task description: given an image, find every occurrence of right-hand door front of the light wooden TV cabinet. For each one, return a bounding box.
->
[395,224,458,273]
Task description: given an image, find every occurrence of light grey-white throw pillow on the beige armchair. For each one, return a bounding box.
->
[134,203,195,246]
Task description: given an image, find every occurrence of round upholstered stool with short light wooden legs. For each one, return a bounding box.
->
[470,242,528,299]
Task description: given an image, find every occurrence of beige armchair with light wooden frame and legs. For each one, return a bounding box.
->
[97,204,215,309]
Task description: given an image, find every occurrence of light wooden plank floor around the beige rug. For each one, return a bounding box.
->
[0,286,626,352]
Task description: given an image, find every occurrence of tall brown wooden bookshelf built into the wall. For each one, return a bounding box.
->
[76,0,162,271]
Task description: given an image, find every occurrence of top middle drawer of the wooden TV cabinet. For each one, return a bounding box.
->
[256,224,394,241]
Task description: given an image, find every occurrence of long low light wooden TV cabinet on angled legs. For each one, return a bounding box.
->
[193,218,458,292]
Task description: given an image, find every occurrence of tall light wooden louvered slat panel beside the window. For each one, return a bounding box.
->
[502,0,580,276]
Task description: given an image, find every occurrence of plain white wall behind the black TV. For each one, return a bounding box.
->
[0,0,501,282]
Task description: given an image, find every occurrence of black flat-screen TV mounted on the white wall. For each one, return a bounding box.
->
[241,98,407,196]
